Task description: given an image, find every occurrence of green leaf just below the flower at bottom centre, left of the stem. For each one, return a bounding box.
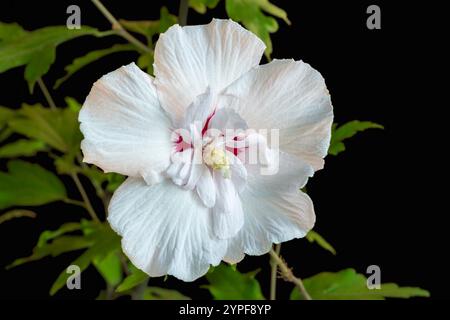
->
[205,264,264,300]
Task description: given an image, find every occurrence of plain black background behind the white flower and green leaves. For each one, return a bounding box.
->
[0,0,449,299]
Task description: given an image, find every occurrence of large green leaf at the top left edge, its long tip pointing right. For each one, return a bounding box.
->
[0,22,108,90]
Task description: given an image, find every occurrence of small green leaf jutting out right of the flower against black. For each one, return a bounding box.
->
[328,120,384,156]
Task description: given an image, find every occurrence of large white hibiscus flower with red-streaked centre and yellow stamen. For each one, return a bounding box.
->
[80,20,333,281]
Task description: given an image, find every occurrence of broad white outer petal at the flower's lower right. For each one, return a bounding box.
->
[225,153,315,256]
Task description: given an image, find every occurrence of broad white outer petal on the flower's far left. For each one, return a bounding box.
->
[79,63,171,182]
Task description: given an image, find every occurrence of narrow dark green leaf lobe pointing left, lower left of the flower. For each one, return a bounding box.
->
[6,236,92,269]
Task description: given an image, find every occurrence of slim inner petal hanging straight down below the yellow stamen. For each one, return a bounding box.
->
[212,171,244,239]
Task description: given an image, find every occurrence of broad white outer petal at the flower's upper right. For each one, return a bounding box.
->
[224,60,333,170]
